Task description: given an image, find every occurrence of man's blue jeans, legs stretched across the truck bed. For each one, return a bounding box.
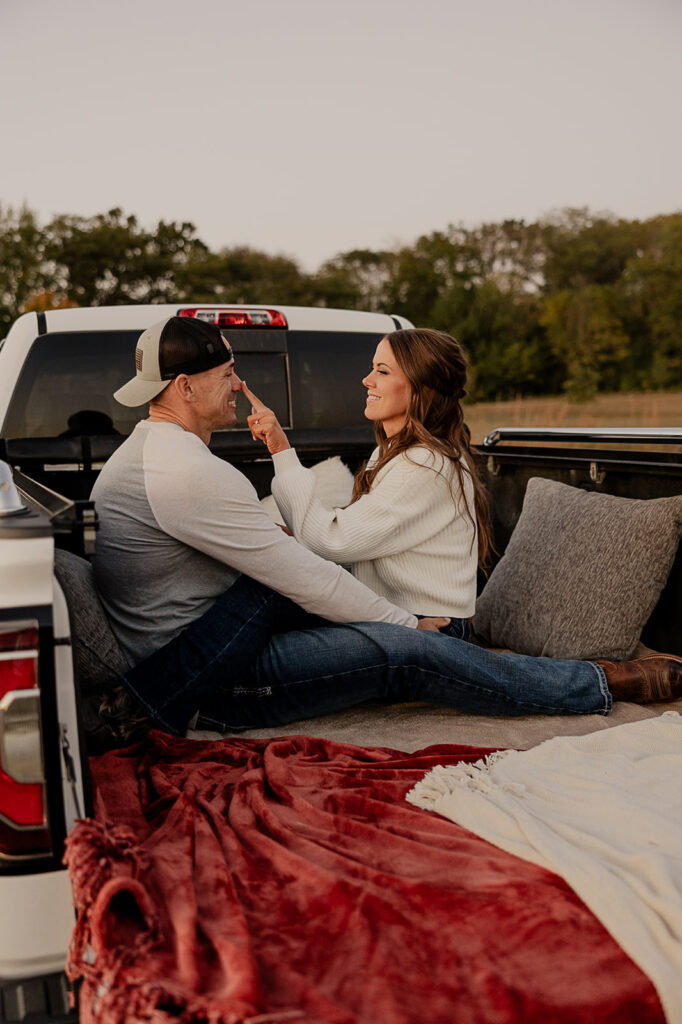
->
[126,577,611,734]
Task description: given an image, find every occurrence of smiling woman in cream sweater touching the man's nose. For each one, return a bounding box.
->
[245,330,491,636]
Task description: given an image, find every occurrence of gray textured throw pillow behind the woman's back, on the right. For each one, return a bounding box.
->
[473,477,682,660]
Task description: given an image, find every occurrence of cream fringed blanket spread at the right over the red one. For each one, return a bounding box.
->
[407,712,682,1024]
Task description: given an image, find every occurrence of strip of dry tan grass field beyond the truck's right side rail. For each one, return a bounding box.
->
[465,391,682,442]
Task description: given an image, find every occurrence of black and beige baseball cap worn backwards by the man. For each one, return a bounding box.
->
[114,316,232,408]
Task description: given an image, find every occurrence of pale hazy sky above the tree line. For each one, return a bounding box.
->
[0,0,682,270]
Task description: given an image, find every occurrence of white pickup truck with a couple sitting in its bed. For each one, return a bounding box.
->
[0,304,682,1024]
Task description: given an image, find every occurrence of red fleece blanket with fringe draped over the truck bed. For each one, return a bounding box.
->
[67,733,664,1024]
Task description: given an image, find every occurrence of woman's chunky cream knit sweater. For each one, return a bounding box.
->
[272,447,477,618]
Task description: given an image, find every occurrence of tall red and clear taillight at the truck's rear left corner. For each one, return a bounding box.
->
[0,623,49,856]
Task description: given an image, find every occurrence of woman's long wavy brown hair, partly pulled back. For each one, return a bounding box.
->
[351,328,493,568]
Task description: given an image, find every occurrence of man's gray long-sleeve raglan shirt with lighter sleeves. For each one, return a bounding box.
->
[92,420,417,665]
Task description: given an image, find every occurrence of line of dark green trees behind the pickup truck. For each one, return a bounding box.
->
[0,207,682,400]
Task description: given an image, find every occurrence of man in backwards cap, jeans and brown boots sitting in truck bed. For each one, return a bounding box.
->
[92,317,682,734]
